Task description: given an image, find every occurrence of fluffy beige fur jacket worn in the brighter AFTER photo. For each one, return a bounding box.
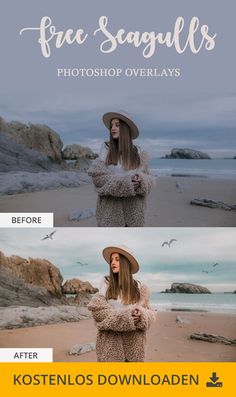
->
[88,285,156,362]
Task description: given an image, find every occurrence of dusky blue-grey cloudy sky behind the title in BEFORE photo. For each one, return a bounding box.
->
[0,0,236,157]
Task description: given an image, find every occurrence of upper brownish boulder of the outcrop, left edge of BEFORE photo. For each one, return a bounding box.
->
[0,118,63,163]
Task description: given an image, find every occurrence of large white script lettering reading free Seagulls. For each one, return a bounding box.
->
[20,16,217,58]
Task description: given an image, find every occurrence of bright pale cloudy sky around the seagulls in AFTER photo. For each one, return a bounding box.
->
[0,228,236,292]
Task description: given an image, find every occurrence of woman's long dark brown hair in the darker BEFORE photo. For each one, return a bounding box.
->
[106,119,140,170]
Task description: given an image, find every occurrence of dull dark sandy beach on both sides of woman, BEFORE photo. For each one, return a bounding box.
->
[0,177,236,227]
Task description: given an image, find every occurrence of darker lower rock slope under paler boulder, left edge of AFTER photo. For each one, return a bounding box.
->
[0,266,67,308]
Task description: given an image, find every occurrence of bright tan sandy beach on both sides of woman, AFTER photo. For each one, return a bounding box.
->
[0,312,236,362]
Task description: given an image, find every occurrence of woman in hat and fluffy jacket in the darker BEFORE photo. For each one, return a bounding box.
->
[88,112,154,227]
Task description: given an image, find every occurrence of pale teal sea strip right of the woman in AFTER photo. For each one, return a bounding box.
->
[150,292,236,314]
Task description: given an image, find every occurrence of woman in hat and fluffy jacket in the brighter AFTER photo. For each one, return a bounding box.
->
[88,246,156,362]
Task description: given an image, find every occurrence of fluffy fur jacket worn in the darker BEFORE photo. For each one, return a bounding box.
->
[88,155,155,227]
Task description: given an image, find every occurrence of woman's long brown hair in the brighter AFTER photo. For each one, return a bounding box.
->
[105,254,140,305]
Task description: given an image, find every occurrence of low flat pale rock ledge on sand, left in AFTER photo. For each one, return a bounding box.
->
[0,305,91,329]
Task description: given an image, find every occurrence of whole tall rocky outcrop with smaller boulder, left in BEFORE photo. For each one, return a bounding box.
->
[0,117,97,173]
